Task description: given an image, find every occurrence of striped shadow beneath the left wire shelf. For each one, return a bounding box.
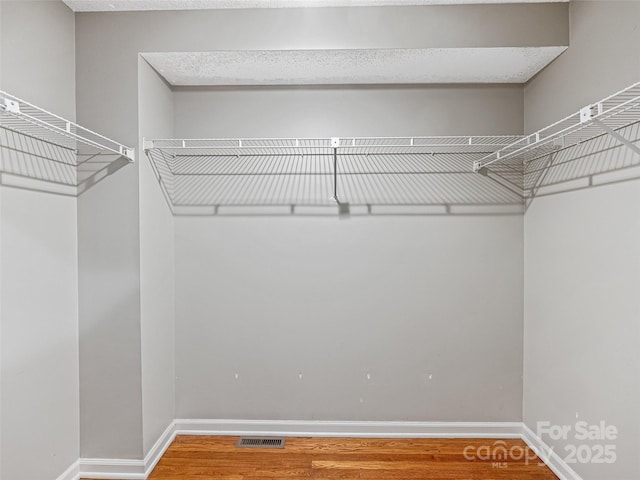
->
[0,125,129,197]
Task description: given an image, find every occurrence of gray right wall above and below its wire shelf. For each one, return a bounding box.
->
[524,1,640,480]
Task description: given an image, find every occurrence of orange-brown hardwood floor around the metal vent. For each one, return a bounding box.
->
[110,435,557,480]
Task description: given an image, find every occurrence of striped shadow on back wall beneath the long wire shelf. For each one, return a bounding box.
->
[147,149,523,217]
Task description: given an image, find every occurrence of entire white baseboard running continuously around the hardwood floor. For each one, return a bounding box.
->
[72,419,582,480]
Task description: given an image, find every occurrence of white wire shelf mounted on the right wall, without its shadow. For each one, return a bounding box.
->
[474,82,640,173]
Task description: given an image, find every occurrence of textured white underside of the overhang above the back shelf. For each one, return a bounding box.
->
[142,46,567,86]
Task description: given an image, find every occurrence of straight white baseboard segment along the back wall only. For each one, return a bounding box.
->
[175,419,522,438]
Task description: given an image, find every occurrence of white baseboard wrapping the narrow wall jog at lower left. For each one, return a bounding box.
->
[79,422,176,480]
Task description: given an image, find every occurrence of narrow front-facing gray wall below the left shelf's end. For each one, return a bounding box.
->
[78,142,142,458]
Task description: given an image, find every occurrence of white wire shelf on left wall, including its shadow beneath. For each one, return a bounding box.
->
[0,91,135,196]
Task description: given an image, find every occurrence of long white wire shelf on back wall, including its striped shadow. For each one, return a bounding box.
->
[144,136,522,215]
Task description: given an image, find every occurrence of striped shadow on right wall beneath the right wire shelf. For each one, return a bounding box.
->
[489,120,640,210]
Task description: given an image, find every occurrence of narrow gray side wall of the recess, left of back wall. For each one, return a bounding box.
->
[138,58,176,455]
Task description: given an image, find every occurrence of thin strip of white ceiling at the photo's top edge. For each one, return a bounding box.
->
[62,0,569,12]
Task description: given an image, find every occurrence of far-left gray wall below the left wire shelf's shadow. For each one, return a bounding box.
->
[1,187,79,480]
